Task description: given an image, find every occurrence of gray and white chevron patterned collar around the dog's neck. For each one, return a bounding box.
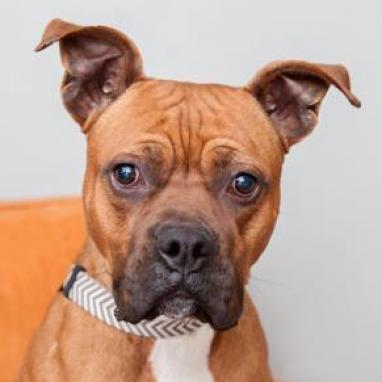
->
[60,265,204,339]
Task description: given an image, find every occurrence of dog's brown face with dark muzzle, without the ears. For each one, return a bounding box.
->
[84,80,283,328]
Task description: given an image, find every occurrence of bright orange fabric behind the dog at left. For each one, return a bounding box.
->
[0,198,85,381]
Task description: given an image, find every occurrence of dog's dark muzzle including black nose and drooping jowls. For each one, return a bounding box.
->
[114,223,243,330]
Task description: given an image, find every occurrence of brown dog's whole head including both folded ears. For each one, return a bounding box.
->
[37,20,359,329]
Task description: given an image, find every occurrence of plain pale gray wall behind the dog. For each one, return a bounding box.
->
[0,0,382,382]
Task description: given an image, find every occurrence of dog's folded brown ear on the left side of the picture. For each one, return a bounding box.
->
[36,19,143,131]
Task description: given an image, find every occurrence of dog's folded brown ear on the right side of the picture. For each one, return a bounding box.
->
[247,61,361,151]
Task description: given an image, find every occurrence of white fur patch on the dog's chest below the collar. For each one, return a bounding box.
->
[150,325,214,382]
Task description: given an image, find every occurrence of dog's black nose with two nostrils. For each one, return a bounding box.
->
[156,225,217,273]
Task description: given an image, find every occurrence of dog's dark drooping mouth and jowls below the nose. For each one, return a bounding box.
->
[113,257,244,330]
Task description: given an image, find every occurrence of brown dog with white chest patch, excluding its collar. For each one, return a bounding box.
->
[19,20,360,382]
